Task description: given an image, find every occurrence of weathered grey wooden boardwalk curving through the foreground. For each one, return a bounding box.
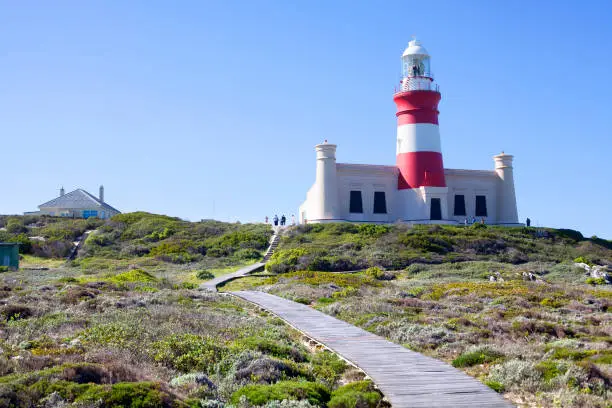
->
[232,292,513,408]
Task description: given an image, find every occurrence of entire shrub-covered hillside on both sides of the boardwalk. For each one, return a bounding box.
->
[0,213,612,408]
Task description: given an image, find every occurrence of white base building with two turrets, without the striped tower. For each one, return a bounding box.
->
[299,144,519,225]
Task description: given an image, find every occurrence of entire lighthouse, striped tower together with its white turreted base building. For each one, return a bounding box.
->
[299,40,518,225]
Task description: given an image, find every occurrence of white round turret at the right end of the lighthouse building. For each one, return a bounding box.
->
[493,152,518,224]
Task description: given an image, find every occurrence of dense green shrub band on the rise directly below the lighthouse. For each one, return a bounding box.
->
[266,223,612,273]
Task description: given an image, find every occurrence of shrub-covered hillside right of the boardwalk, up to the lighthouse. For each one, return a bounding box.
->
[224,224,612,407]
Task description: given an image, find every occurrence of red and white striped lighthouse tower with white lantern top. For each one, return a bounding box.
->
[393,39,446,190]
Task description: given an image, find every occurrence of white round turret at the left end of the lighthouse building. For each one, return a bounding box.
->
[309,140,339,221]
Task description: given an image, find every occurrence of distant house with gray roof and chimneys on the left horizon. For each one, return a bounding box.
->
[25,186,121,219]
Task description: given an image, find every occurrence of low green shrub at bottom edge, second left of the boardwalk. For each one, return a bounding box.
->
[231,381,330,406]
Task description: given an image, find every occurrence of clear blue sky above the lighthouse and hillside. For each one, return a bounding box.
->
[0,0,612,238]
